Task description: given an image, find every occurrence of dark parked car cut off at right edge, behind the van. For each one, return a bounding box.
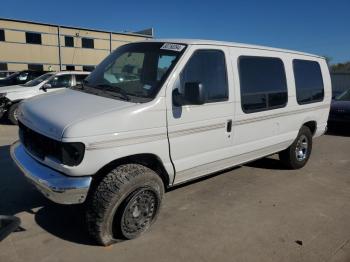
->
[328,88,350,127]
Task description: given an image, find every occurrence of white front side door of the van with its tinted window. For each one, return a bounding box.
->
[167,45,234,184]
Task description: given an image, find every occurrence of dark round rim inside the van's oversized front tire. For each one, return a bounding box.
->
[121,189,159,238]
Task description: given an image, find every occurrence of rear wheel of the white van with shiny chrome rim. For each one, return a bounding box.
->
[279,126,312,169]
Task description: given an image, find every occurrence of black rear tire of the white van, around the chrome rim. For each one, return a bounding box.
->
[279,126,312,169]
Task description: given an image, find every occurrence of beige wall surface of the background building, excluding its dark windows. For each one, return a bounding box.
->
[0,19,145,70]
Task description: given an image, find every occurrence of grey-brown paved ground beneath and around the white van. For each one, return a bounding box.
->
[0,125,350,262]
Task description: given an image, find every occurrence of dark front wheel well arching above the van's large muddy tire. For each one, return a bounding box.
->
[93,154,169,188]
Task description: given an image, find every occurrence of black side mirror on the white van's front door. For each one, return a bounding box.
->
[173,82,206,106]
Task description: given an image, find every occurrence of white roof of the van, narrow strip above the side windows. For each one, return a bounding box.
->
[146,39,325,59]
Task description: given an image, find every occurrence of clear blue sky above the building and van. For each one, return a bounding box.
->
[0,0,350,63]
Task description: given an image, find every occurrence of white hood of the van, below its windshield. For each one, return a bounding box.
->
[18,89,135,140]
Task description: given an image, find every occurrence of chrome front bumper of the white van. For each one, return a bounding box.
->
[11,142,92,204]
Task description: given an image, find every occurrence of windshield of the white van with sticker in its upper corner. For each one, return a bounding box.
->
[78,42,186,103]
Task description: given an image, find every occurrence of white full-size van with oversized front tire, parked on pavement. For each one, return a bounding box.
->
[11,40,331,245]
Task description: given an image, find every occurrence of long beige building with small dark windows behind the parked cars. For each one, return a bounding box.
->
[0,18,153,71]
